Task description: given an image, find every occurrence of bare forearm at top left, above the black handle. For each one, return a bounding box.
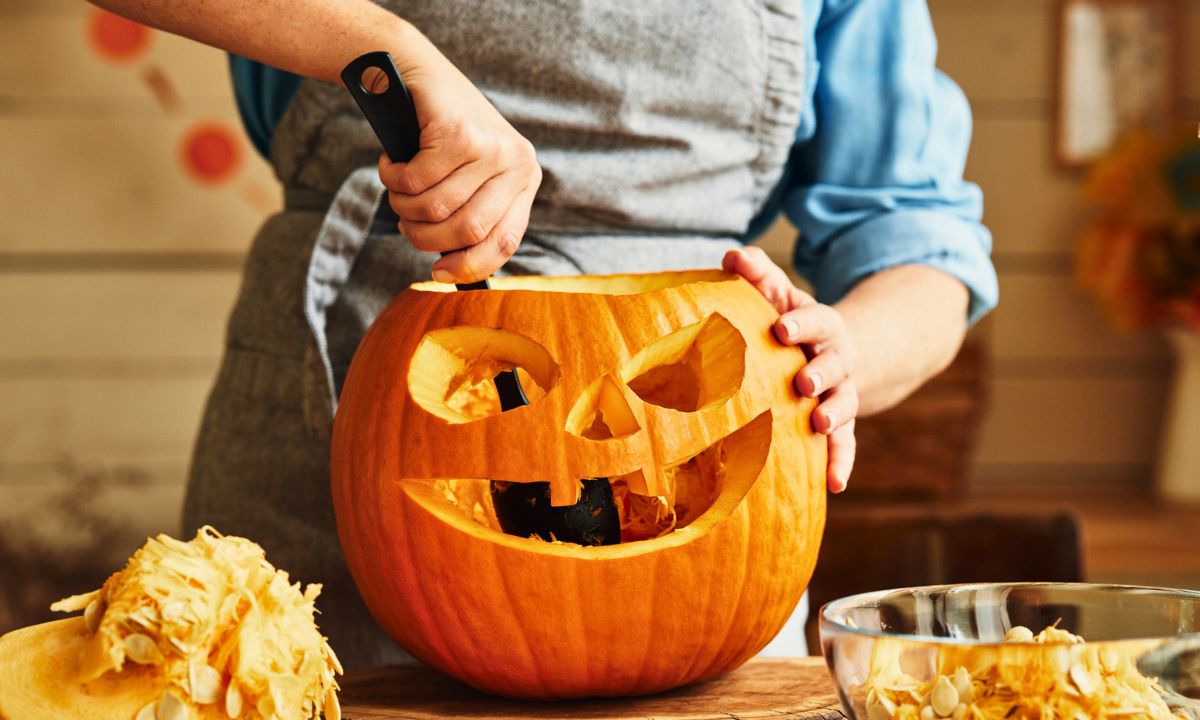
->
[85,0,442,83]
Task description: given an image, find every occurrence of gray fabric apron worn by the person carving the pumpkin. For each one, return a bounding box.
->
[184,0,804,667]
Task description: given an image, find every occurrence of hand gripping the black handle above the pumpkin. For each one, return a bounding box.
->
[379,55,541,283]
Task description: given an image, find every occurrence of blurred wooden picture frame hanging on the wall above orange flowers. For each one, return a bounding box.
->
[1054,0,1182,169]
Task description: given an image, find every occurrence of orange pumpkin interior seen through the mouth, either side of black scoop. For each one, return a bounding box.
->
[417,413,770,551]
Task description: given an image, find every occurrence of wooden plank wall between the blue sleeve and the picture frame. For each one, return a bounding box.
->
[930,0,1200,486]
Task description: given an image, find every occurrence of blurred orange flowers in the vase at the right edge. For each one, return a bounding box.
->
[1075,128,1200,331]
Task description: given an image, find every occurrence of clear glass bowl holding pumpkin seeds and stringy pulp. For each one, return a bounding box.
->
[821,583,1200,720]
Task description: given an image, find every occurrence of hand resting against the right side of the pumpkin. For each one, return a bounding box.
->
[721,246,858,492]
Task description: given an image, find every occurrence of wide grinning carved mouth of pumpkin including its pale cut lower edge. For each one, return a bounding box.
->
[400,410,772,554]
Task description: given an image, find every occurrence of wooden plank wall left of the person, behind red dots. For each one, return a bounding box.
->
[0,0,278,631]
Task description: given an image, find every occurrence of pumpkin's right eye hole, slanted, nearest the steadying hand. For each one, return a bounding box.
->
[620,314,746,413]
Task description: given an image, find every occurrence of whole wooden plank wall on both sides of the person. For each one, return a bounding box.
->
[0,0,1200,630]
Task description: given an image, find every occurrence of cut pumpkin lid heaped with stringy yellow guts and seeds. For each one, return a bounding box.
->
[0,528,342,720]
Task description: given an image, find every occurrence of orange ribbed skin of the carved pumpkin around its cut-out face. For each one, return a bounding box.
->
[331,271,826,700]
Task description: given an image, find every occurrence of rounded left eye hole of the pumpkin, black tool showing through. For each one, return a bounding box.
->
[408,325,558,424]
